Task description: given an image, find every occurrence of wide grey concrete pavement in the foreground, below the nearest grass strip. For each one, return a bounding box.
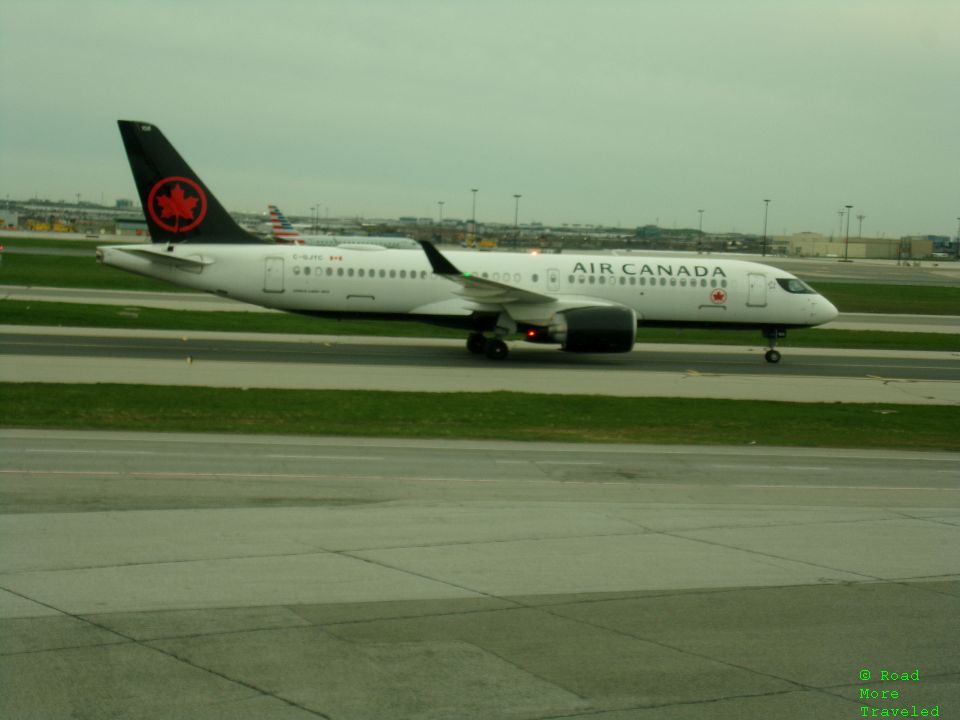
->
[0,430,960,720]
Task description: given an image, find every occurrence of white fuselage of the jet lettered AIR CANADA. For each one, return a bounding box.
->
[100,244,837,327]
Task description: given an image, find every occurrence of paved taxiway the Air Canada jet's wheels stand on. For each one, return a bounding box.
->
[0,326,960,405]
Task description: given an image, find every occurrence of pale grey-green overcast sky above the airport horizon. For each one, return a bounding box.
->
[0,0,960,236]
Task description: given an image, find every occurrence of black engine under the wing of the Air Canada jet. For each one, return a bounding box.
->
[527,307,637,352]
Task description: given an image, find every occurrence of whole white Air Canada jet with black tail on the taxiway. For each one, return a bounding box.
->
[97,120,837,363]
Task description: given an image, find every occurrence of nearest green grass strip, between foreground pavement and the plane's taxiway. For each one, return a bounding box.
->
[0,383,960,451]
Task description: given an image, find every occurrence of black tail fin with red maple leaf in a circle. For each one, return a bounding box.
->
[117,120,263,243]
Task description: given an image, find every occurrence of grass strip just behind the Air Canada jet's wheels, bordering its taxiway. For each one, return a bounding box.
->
[0,300,960,352]
